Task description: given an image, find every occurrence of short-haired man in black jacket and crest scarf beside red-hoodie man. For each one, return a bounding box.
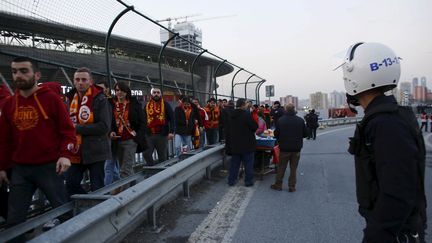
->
[66,67,111,196]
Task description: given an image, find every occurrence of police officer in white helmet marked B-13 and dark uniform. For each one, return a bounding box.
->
[342,43,426,242]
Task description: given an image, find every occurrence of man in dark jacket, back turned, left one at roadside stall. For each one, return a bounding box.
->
[226,98,258,187]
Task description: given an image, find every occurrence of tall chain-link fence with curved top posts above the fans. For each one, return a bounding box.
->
[0,0,265,103]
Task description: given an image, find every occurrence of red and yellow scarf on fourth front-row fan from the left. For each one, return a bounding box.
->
[146,99,166,134]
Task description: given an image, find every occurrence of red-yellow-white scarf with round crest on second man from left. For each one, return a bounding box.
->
[69,86,98,164]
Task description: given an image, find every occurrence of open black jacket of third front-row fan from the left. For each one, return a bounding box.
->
[111,97,147,153]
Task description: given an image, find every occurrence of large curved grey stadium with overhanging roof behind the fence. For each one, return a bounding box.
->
[0,11,234,94]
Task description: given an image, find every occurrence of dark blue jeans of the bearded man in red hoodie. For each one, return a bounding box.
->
[7,162,67,226]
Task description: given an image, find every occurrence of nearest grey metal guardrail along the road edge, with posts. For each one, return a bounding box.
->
[26,144,225,242]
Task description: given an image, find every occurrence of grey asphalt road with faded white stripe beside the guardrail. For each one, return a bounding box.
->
[123,126,432,243]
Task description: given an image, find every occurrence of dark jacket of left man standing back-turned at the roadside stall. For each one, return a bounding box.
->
[225,109,258,154]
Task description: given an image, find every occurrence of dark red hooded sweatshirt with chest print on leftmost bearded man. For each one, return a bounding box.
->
[0,87,76,170]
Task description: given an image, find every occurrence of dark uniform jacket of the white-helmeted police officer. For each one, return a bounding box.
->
[349,95,426,242]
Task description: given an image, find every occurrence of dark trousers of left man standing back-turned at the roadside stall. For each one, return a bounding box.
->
[228,152,255,185]
